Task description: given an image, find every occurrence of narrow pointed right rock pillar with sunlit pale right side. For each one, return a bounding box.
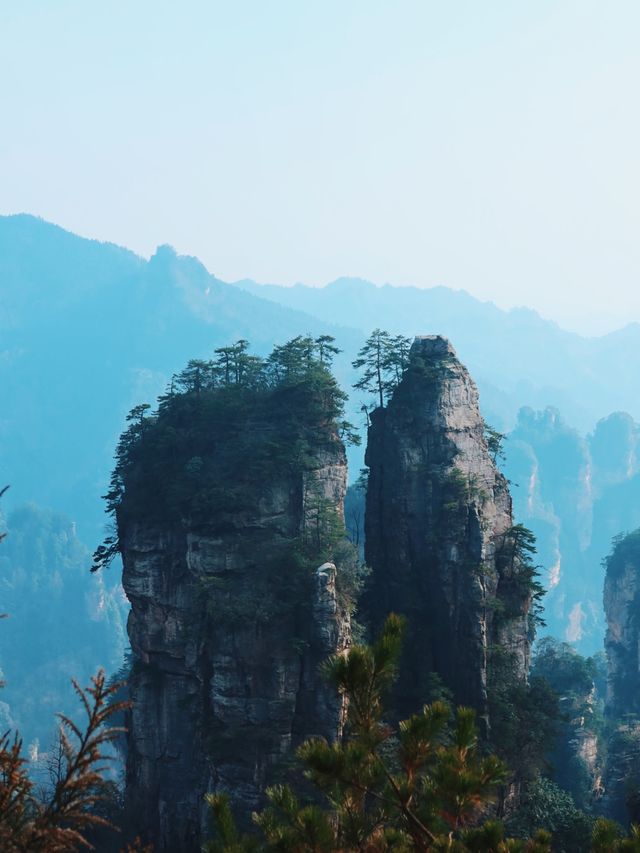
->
[365,336,530,719]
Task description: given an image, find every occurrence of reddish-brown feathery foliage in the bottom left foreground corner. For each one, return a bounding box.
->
[0,670,128,853]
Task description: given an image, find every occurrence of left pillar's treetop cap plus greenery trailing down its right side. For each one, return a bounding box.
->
[93,335,363,631]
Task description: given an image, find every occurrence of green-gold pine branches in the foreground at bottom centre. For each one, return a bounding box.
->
[203,615,551,853]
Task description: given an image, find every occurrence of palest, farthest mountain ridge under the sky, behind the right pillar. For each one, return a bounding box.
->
[236,278,640,432]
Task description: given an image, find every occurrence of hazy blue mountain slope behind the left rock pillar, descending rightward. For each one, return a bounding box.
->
[0,215,360,543]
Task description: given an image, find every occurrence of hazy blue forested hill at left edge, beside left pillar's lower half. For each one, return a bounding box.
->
[0,505,126,752]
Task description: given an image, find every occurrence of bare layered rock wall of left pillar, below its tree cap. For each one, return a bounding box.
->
[119,423,350,853]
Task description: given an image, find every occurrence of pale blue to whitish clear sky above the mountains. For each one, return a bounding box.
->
[0,0,640,334]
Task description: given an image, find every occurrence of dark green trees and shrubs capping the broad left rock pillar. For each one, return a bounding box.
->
[93,335,360,571]
